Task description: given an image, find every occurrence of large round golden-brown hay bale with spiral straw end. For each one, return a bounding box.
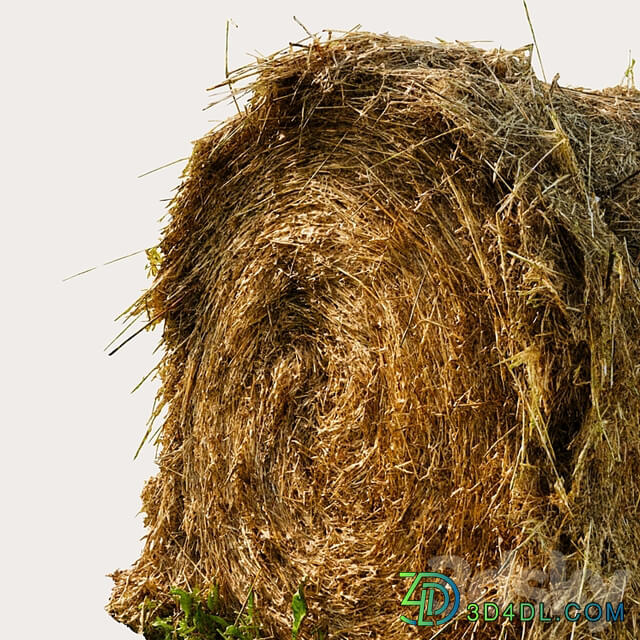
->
[110,33,640,640]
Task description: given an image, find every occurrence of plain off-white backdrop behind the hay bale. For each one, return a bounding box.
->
[0,0,640,640]
